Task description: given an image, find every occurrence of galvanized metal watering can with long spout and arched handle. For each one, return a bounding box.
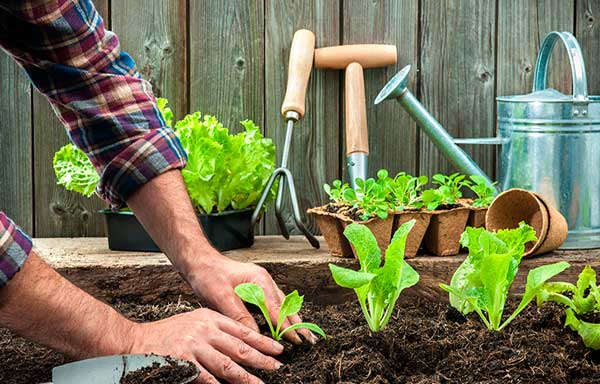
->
[375,32,600,249]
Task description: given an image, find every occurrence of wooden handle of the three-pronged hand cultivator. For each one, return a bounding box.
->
[281,29,315,118]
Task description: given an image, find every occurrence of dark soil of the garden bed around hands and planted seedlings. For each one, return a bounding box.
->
[0,299,600,384]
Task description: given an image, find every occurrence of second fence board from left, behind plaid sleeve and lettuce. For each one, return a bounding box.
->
[32,0,108,237]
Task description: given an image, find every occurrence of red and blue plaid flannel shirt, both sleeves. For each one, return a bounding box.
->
[0,0,186,286]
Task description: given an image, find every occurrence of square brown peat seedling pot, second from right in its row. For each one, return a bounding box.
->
[423,205,471,256]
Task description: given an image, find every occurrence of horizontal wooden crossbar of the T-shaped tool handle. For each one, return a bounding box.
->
[315,44,398,69]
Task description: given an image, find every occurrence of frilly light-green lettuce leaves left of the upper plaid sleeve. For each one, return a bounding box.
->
[52,144,100,197]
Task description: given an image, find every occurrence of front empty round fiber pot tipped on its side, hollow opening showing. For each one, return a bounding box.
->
[485,188,548,256]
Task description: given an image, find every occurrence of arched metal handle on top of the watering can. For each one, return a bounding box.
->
[533,31,588,102]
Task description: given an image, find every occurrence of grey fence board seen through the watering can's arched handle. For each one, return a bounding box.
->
[496,0,575,100]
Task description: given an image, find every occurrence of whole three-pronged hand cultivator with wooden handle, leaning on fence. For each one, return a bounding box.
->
[251,29,320,248]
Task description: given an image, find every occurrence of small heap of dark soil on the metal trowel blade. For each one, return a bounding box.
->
[119,359,196,384]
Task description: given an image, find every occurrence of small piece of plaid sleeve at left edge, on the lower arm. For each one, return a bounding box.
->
[0,211,32,288]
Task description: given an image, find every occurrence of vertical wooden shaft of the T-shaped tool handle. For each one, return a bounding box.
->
[344,63,369,155]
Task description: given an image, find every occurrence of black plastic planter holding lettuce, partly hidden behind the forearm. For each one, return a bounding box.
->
[100,208,254,252]
